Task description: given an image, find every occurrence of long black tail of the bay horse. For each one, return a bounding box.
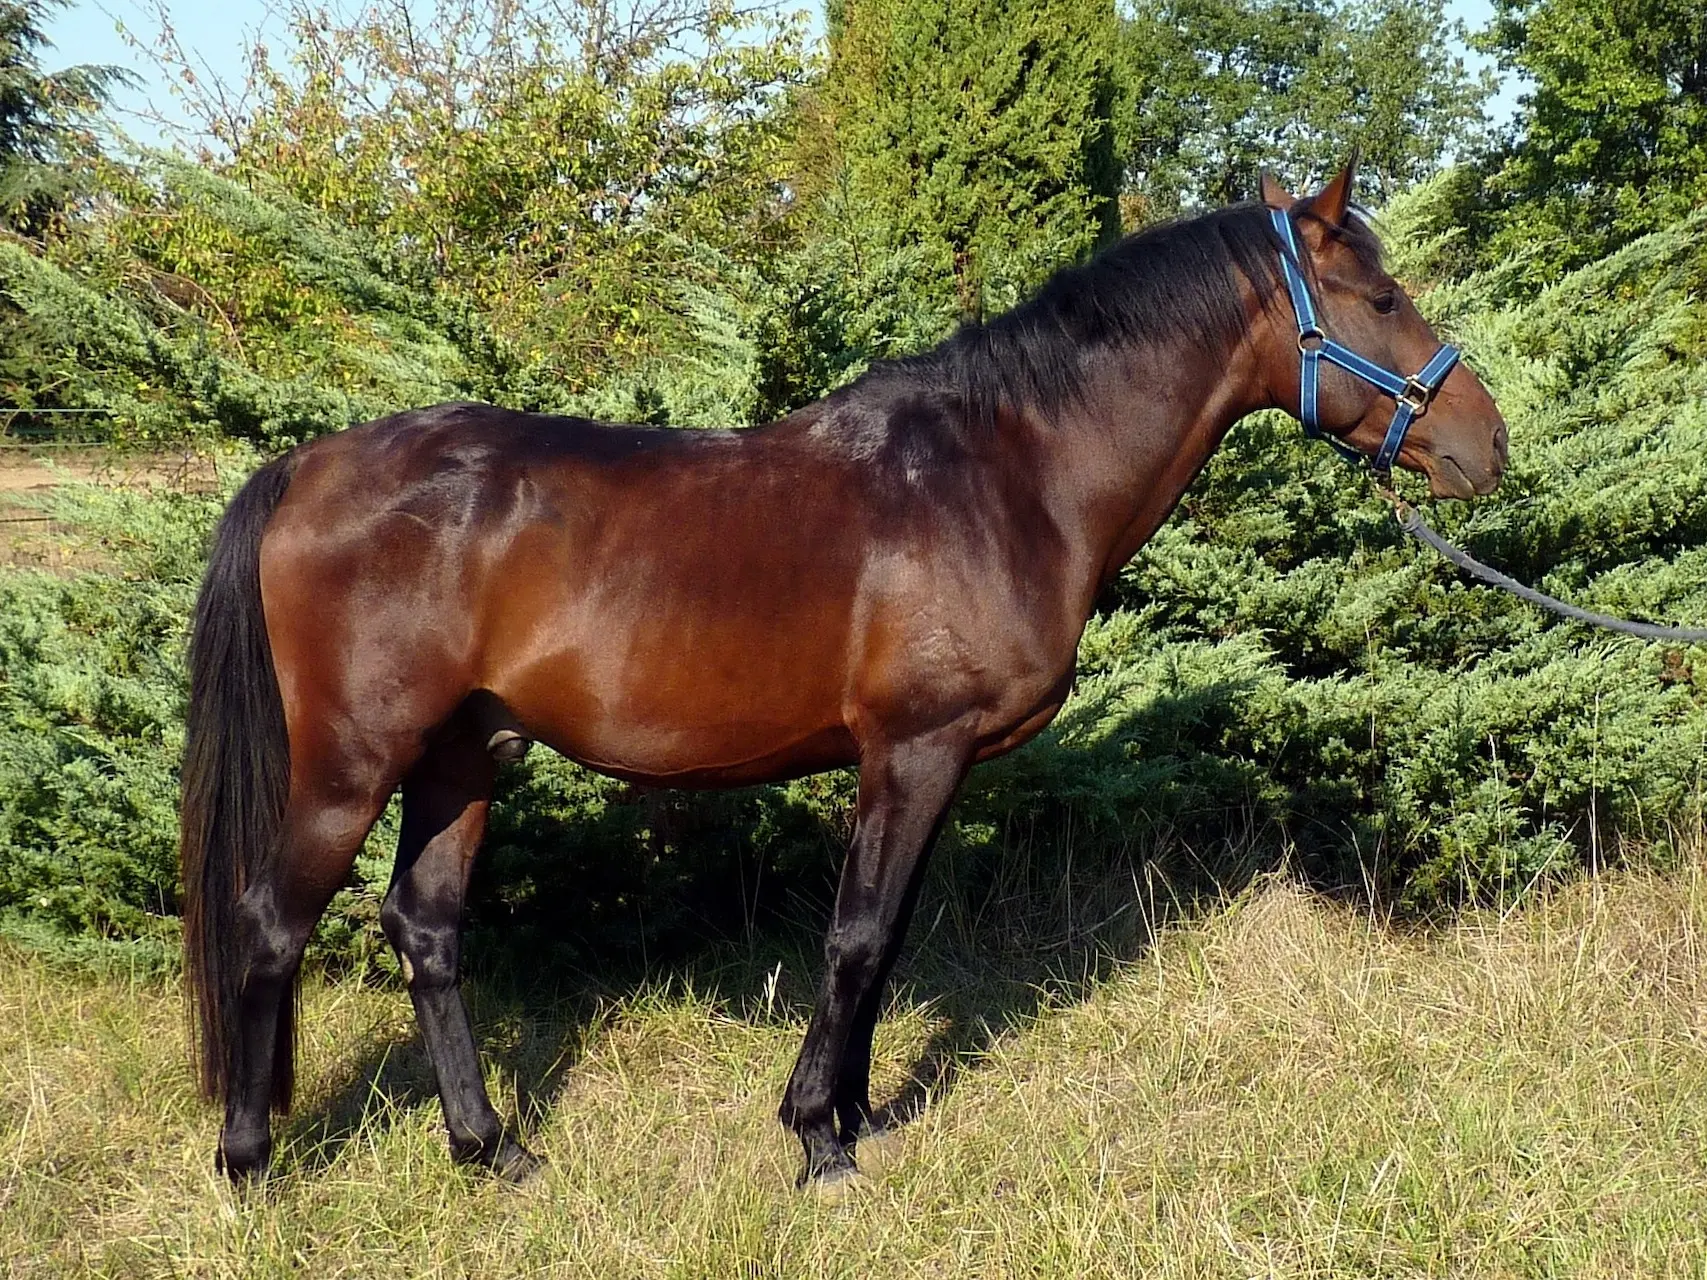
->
[179,456,297,1109]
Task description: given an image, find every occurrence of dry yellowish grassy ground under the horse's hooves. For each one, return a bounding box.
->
[0,865,1707,1280]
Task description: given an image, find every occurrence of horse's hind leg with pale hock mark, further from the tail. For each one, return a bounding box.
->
[379,732,538,1181]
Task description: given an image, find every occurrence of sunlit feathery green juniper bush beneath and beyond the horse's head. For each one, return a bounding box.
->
[1086,205,1707,905]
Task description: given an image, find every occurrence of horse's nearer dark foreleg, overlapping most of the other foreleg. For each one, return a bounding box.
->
[780,732,968,1184]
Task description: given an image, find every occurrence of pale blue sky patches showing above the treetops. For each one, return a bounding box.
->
[44,0,1518,154]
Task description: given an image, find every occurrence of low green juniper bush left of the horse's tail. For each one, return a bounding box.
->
[0,486,217,939]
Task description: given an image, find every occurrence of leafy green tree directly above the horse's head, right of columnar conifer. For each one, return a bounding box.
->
[1121,0,1489,222]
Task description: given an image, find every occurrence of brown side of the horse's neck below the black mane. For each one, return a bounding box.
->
[1046,327,1272,592]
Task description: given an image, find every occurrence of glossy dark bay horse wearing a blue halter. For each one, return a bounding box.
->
[181,166,1506,1183]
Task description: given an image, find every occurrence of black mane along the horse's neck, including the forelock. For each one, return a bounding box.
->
[860,203,1381,420]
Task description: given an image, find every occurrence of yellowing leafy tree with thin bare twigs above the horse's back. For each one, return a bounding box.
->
[153,0,809,404]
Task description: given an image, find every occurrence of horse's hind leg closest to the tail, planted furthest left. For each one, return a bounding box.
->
[218,770,393,1181]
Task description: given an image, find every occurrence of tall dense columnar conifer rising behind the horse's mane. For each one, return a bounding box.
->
[804,0,1118,323]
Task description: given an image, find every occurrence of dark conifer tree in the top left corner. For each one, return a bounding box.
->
[0,0,123,236]
